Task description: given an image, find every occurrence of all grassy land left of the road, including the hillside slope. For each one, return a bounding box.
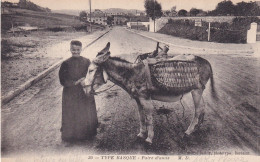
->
[1,8,104,96]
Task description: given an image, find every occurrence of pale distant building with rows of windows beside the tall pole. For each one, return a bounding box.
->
[87,9,107,25]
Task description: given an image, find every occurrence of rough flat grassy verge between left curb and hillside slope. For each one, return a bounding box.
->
[1,32,94,96]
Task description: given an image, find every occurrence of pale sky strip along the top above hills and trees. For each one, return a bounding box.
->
[5,0,253,11]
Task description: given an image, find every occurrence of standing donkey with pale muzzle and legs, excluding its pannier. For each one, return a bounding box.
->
[82,43,215,144]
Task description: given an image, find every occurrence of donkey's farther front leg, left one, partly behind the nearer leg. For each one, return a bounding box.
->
[135,98,146,138]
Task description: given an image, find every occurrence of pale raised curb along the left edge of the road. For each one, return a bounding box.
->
[1,29,111,105]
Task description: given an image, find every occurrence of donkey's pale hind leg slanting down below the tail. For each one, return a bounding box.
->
[185,89,204,135]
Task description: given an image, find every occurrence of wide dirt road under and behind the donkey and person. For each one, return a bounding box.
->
[1,27,260,157]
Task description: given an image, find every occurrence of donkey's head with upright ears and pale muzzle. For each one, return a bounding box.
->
[85,42,110,94]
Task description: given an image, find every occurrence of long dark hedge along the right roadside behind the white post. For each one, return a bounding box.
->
[158,17,260,43]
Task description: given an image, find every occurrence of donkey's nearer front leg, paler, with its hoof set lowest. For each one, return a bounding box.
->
[140,98,154,144]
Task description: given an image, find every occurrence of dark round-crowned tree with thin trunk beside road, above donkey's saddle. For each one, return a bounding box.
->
[144,0,163,32]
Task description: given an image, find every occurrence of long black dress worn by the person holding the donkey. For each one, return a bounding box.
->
[59,56,98,141]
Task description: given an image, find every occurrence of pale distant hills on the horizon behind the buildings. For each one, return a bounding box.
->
[52,8,144,16]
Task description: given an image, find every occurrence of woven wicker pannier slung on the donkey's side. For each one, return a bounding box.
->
[149,60,199,94]
